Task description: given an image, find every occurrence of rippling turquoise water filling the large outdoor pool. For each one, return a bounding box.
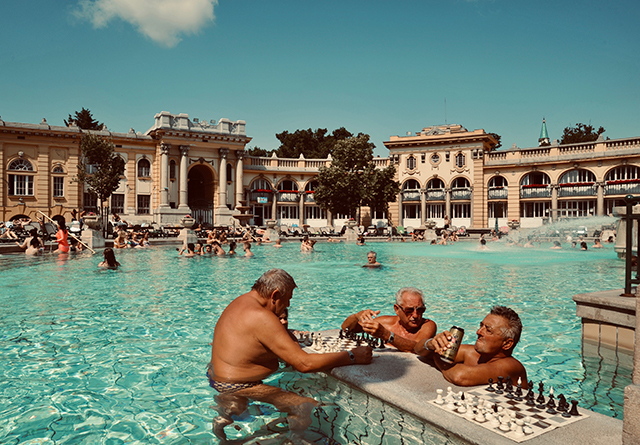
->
[0,243,631,444]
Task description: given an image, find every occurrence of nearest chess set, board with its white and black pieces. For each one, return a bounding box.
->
[430,377,589,442]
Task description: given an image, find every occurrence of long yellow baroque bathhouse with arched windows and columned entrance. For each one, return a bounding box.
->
[0,111,640,229]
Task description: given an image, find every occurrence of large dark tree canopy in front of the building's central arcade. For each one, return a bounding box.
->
[314,133,400,221]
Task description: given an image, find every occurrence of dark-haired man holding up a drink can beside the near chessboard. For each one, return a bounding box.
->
[414,306,528,389]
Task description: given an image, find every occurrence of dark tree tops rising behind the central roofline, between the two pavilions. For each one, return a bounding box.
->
[276,127,353,159]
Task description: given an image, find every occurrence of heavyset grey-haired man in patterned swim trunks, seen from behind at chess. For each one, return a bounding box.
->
[207,269,372,441]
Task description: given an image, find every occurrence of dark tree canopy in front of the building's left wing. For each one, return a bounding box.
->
[75,133,124,202]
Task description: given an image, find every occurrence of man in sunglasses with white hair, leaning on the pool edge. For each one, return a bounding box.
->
[342,287,437,352]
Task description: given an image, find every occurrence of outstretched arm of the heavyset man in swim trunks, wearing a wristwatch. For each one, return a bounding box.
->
[256,315,372,372]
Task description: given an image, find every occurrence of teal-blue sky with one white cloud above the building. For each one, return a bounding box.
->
[0,0,640,156]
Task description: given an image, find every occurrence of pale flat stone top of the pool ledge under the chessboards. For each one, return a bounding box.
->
[323,330,622,445]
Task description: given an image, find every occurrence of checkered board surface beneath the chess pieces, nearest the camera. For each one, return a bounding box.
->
[429,388,589,443]
